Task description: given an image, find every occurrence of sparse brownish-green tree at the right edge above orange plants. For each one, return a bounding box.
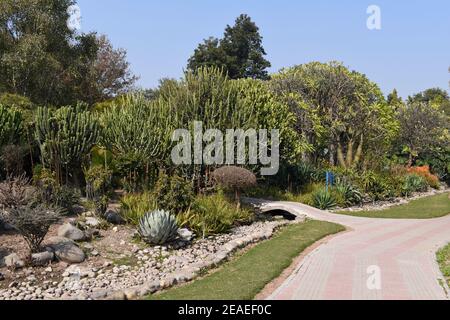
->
[398,102,450,166]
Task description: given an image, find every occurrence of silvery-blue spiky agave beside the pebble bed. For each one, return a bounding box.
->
[139,210,178,245]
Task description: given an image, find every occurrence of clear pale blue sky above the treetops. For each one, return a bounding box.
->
[78,0,450,97]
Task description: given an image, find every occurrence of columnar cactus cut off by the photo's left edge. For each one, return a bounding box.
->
[0,105,23,149]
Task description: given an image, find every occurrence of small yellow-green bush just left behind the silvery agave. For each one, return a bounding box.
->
[120,192,157,226]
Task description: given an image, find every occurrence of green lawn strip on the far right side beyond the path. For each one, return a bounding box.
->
[338,193,450,219]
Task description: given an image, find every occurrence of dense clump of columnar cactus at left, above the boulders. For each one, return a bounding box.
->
[35,105,100,184]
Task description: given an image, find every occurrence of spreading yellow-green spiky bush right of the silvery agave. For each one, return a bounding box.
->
[177,192,254,237]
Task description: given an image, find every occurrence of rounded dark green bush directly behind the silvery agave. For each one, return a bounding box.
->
[153,172,194,214]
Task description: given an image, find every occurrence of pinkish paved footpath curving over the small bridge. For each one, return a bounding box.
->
[269,202,450,300]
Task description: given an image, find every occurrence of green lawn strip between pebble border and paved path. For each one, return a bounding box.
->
[149,221,345,300]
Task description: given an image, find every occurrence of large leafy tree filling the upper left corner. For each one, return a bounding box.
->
[0,0,136,106]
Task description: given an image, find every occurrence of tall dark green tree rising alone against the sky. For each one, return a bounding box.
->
[188,14,271,79]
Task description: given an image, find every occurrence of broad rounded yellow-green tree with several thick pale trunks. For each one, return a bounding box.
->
[271,62,396,167]
